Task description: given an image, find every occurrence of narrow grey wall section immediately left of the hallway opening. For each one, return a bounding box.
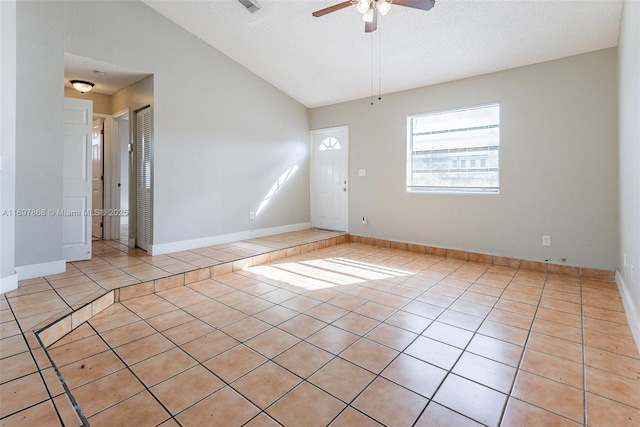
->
[15,1,64,279]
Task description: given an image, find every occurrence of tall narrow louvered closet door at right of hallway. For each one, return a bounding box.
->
[136,107,151,251]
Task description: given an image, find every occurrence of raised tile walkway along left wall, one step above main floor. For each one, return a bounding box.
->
[0,230,343,426]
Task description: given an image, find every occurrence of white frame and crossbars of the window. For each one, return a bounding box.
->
[406,102,502,194]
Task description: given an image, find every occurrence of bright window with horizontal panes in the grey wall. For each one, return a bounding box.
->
[407,104,500,193]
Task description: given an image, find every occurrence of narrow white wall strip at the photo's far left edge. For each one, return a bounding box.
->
[0,1,18,294]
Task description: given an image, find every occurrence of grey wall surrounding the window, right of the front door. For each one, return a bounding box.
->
[309,48,618,270]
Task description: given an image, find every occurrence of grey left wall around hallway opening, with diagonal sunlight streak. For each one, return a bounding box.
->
[11,1,309,265]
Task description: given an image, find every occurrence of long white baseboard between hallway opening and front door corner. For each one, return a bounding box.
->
[149,222,311,255]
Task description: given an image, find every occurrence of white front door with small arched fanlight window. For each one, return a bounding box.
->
[311,126,349,231]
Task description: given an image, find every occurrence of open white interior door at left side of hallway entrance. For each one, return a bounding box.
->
[62,98,93,261]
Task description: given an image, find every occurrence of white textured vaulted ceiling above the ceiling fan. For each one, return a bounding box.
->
[143,0,623,107]
